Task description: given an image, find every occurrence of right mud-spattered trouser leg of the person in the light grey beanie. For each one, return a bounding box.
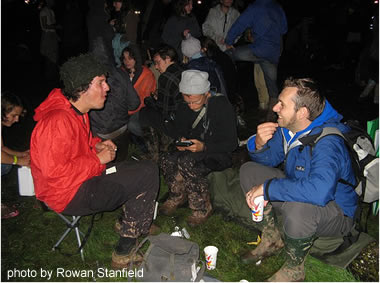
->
[178,152,211,213]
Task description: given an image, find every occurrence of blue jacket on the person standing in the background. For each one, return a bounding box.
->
[225,0,288,64]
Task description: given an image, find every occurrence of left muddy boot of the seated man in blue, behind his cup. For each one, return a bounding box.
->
[241,206,284,263]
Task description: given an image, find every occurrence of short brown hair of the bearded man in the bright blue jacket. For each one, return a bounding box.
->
[283,77,325,121]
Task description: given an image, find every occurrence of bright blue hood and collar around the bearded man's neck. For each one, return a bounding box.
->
[282,99,346,142]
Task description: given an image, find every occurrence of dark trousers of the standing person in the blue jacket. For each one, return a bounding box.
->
[226,44,278,98]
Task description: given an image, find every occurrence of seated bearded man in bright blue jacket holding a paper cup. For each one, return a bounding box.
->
[240,78,357,281]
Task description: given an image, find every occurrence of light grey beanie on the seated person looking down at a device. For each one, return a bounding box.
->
[179,70,210,95]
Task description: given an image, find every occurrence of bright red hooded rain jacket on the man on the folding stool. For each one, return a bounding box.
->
[30,89,106,212]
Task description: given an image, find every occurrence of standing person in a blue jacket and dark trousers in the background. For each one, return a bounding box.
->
[225,0,288,120]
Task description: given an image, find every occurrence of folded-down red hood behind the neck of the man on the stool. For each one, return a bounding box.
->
[33,88,71,122]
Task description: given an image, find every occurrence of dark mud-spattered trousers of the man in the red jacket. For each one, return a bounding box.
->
[63,160,159,238]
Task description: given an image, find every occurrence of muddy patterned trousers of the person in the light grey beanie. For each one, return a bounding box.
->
[159,151,211,211]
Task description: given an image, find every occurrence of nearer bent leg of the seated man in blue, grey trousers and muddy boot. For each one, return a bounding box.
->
[268,201,353,281]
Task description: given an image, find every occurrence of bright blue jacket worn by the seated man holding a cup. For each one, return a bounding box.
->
[247,101,357,218]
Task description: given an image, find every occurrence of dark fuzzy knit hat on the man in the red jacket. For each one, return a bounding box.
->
[60,53,108,102]
